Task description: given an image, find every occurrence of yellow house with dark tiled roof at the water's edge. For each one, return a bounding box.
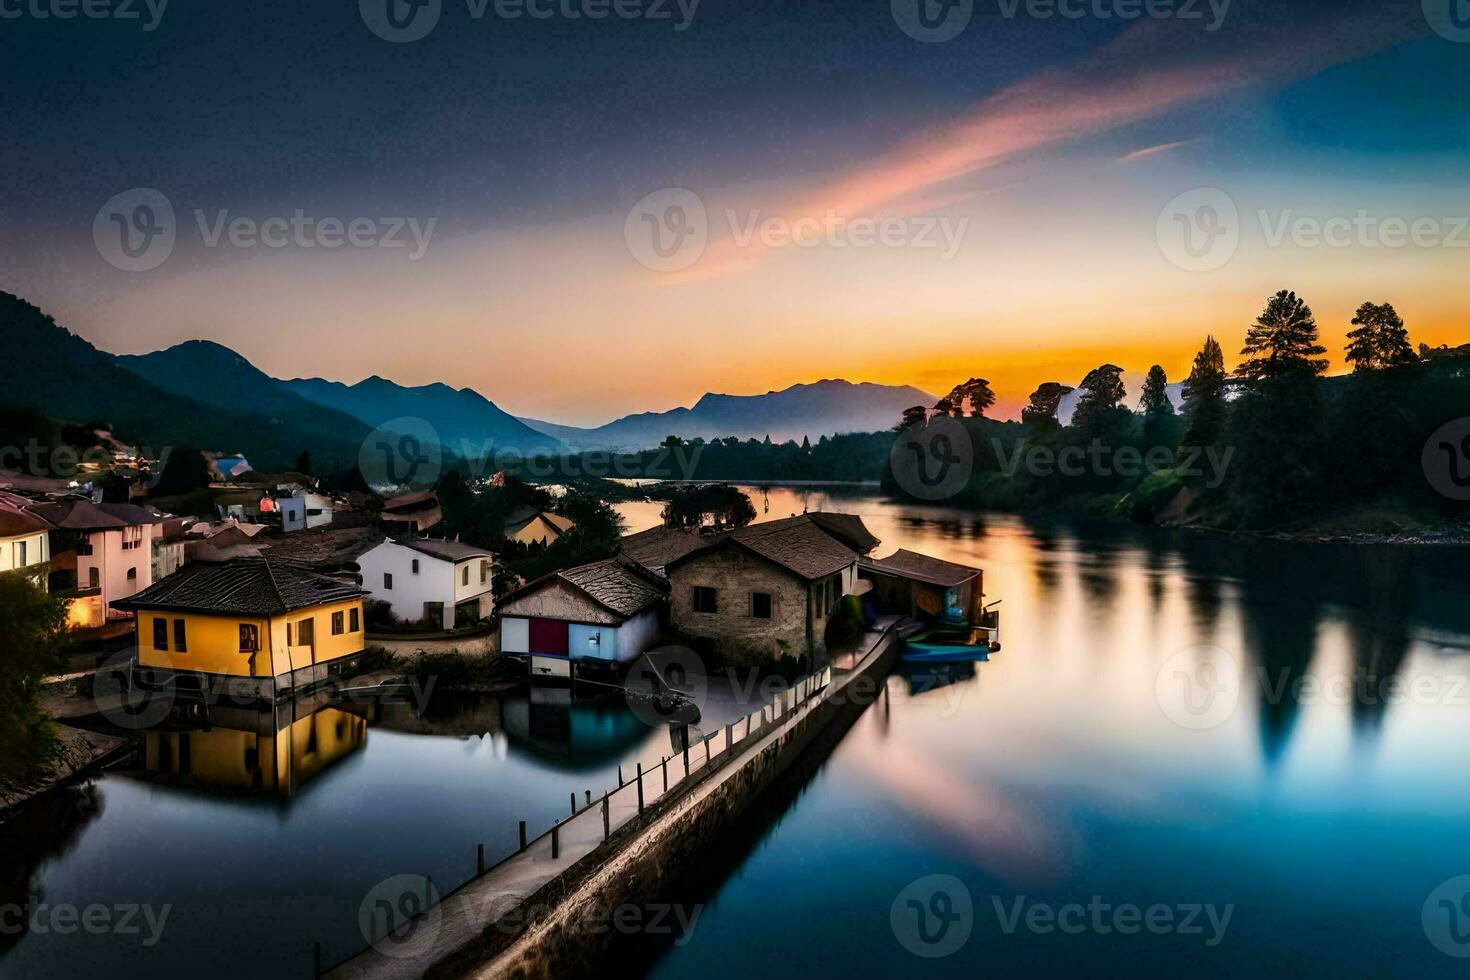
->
[115,558,366,702]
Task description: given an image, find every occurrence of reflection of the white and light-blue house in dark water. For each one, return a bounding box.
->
[501,686,655,773]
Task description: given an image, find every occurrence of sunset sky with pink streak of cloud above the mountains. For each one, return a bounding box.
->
[0,0,1470,425]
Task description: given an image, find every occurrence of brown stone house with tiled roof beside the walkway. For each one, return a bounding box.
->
[664,514,878,664]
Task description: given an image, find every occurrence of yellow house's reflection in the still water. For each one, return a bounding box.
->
[143,699,368,796]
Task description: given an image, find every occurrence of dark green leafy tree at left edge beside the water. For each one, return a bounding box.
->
[0,572,66,785]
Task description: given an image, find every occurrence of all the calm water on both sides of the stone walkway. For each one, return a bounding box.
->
[0,489,1470,980]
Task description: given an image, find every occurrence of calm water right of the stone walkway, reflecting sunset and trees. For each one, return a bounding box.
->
[637,491,1470,977]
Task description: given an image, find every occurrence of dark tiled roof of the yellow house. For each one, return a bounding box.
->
[112,558,368,616]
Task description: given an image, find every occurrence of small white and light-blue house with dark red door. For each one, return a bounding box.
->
[500,557,669,677]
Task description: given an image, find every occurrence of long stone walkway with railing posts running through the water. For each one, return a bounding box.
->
[326,617,904,980]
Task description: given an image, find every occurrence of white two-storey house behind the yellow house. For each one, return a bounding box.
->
[357,536,494,629]
